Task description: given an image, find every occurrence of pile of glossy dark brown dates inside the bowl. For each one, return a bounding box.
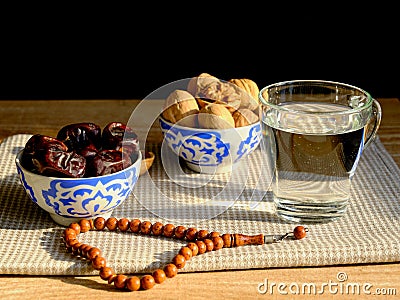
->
[21,122,140,178]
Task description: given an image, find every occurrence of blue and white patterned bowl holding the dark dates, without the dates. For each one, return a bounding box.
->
[15,150,142,226]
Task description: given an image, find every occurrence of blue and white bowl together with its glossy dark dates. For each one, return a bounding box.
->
[15,122,142,226]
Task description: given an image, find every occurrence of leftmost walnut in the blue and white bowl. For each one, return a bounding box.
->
[162,90,199,127]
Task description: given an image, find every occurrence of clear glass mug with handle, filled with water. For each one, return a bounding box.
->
[259,80,382,223]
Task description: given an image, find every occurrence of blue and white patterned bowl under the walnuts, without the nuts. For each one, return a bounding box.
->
[159,116,261,174]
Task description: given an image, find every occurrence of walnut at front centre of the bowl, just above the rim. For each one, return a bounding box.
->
[198,103,235,129]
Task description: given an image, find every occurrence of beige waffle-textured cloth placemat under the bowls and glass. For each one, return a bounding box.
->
[0,135,400,275]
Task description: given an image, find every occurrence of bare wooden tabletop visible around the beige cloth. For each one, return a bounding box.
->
[0,98,400,299]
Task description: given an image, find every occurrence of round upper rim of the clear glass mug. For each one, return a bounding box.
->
[258,79,374,115]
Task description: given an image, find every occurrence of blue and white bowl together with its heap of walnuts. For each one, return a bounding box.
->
[159,73,261,174]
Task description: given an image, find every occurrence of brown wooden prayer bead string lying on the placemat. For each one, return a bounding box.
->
[62,217,307,291]
